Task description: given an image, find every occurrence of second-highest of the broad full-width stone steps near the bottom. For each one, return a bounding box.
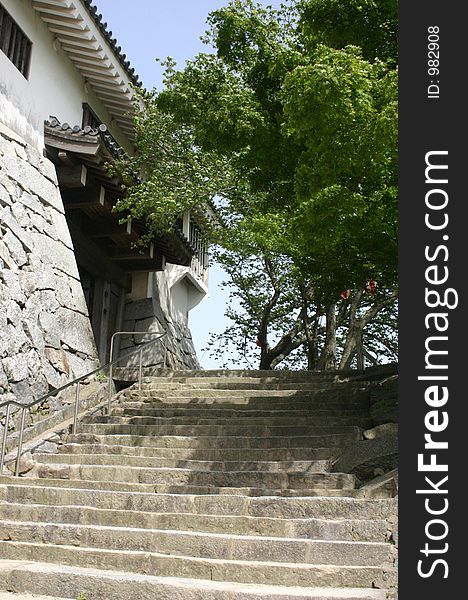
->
[0,502,388,542]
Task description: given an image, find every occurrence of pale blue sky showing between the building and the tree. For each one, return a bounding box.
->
[94,0,280,369]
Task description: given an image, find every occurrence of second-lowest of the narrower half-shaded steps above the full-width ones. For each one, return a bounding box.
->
[33,464,356,490]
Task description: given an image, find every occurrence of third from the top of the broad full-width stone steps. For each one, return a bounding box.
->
[0,520,392,566]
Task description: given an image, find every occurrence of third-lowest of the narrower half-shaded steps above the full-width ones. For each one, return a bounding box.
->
[34,452,331,473]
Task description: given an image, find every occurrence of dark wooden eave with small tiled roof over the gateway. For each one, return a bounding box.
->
[44,119,193,272]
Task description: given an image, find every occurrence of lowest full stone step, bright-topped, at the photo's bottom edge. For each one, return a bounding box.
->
[0,561,386,600]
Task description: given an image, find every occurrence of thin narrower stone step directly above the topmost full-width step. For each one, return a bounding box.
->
[0,476,361,498]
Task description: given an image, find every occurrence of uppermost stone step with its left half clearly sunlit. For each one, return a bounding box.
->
[67,434,362,450]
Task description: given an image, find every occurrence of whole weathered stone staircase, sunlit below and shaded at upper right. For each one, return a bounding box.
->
[0,371,396,600]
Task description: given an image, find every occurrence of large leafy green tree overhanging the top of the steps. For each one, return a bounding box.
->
[118,0,397,367]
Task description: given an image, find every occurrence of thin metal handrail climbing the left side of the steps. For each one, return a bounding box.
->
[0,331,167,477]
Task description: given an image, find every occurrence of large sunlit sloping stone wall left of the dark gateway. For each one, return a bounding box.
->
[0,124,97,424]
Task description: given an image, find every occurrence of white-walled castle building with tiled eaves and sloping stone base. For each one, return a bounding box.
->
[0,0,208,408]
